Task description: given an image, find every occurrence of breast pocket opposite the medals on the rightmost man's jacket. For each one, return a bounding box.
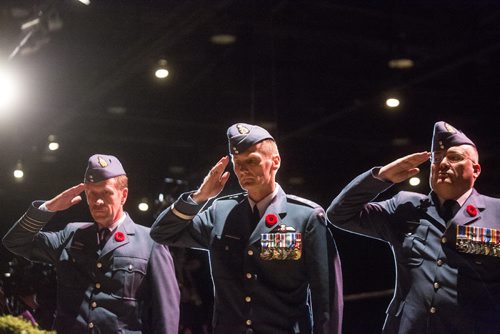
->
[402,222,429,267]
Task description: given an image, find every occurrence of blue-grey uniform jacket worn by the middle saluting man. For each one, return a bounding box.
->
[151,188,343,334]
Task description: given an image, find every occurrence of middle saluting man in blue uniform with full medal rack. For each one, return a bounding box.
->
[151,123,343,334]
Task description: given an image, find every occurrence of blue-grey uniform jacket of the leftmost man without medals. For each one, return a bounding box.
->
[3,202,179,334]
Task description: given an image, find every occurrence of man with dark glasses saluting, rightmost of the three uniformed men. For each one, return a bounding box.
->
[327,122,500,334]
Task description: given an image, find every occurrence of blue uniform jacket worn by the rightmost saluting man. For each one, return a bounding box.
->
[327,171,500,334]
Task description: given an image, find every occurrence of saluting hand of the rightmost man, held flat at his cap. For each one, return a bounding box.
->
[377,151,431,183]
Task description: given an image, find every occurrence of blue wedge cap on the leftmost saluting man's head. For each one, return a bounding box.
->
[84,154,126,183]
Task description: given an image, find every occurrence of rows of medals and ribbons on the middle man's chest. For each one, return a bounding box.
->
[260,225,302,260]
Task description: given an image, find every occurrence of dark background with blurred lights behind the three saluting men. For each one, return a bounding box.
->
[0,0,500,333]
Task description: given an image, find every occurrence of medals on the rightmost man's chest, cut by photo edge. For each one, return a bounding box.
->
[456,226,500,257]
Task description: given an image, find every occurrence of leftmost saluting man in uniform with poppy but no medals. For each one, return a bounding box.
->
[3,154,179,334]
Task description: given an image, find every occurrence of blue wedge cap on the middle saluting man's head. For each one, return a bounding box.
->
[227,123,274,154]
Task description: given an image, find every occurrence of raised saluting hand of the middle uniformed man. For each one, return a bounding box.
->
[191,155,229,203]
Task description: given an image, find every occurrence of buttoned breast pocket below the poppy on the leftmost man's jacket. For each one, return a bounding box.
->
[111,256,148,300]
